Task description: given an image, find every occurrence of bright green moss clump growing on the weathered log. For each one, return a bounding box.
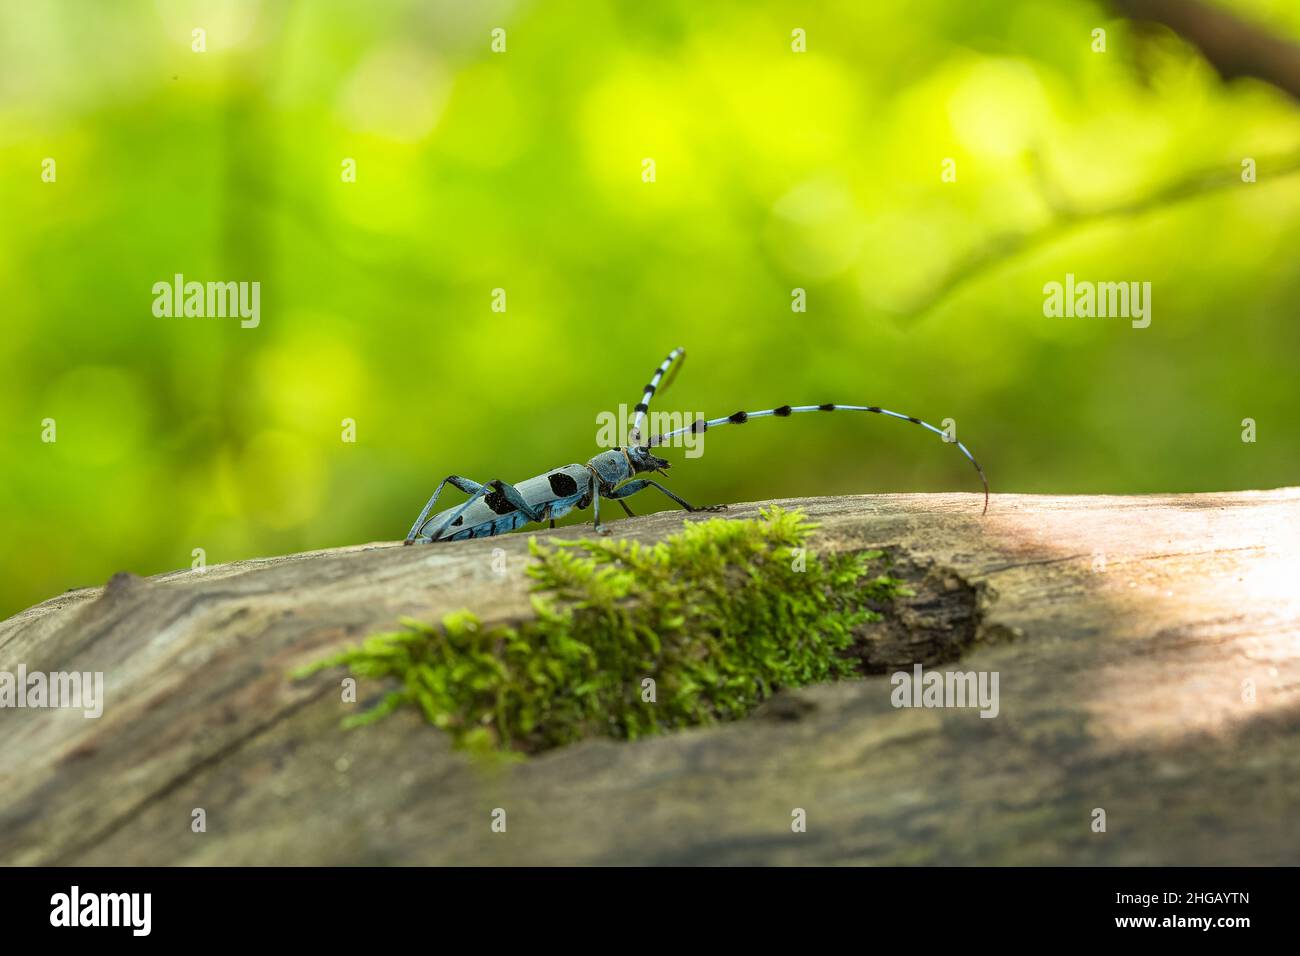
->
[295,507,904,752]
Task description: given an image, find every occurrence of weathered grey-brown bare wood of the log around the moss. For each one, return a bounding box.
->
[0,489,1300,865]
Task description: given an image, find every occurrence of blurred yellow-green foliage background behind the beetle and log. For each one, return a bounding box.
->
[0,0,1300,614]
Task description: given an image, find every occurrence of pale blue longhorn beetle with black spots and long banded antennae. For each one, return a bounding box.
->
[406,349,988,545]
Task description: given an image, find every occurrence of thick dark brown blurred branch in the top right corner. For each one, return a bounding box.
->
[1110,0,1300,100]
